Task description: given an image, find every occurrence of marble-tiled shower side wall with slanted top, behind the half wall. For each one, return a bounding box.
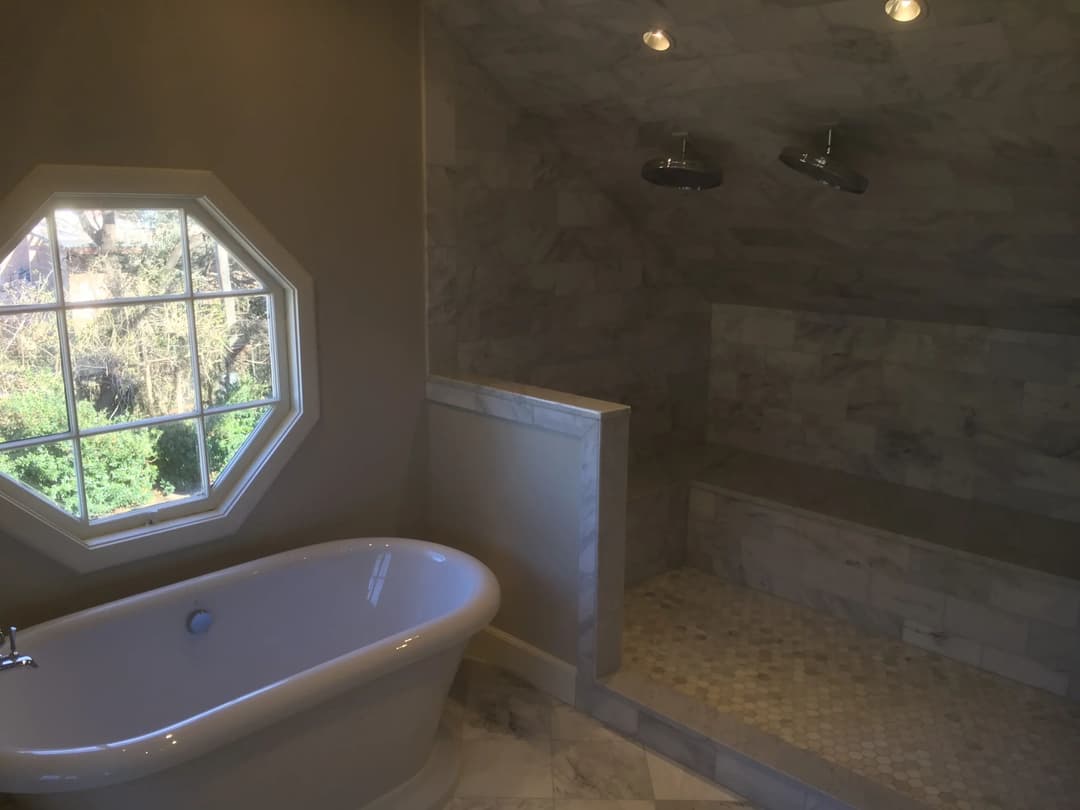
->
[426,17,708,458]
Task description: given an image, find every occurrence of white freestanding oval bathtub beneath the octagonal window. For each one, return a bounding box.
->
[0,538,499,810]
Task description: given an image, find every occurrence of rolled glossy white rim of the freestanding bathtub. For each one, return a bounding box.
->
[0,537,500,794]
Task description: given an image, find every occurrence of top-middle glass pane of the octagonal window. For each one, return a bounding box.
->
[56,208,184,302]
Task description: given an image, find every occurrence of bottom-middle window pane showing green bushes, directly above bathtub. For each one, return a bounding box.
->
[82,420,204,519]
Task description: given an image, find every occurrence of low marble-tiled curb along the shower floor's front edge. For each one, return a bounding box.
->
[578,672,930,810]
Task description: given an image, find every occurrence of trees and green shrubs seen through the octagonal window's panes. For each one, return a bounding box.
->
[0,211,273,518]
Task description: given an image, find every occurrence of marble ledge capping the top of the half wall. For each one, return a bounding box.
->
[428,375,630,436]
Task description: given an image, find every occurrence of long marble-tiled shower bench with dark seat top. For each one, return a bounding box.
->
[687,447,1080,700]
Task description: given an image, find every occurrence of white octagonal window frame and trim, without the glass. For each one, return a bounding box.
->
[0,165,319,571]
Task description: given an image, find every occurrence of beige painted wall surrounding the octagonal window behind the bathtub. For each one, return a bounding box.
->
[0,0,424,624]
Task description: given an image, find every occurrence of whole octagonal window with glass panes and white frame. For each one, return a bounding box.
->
[0,165,313,568]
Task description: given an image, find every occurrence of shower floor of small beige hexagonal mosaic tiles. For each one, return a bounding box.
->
[623,569,1080,810]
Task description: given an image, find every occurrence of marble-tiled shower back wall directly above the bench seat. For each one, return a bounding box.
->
[708,305,1080,522]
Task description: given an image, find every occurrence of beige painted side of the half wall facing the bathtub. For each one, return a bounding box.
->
[428,403,582,663]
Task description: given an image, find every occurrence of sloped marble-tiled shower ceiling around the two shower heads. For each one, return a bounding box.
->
[430,0,1080,332]
